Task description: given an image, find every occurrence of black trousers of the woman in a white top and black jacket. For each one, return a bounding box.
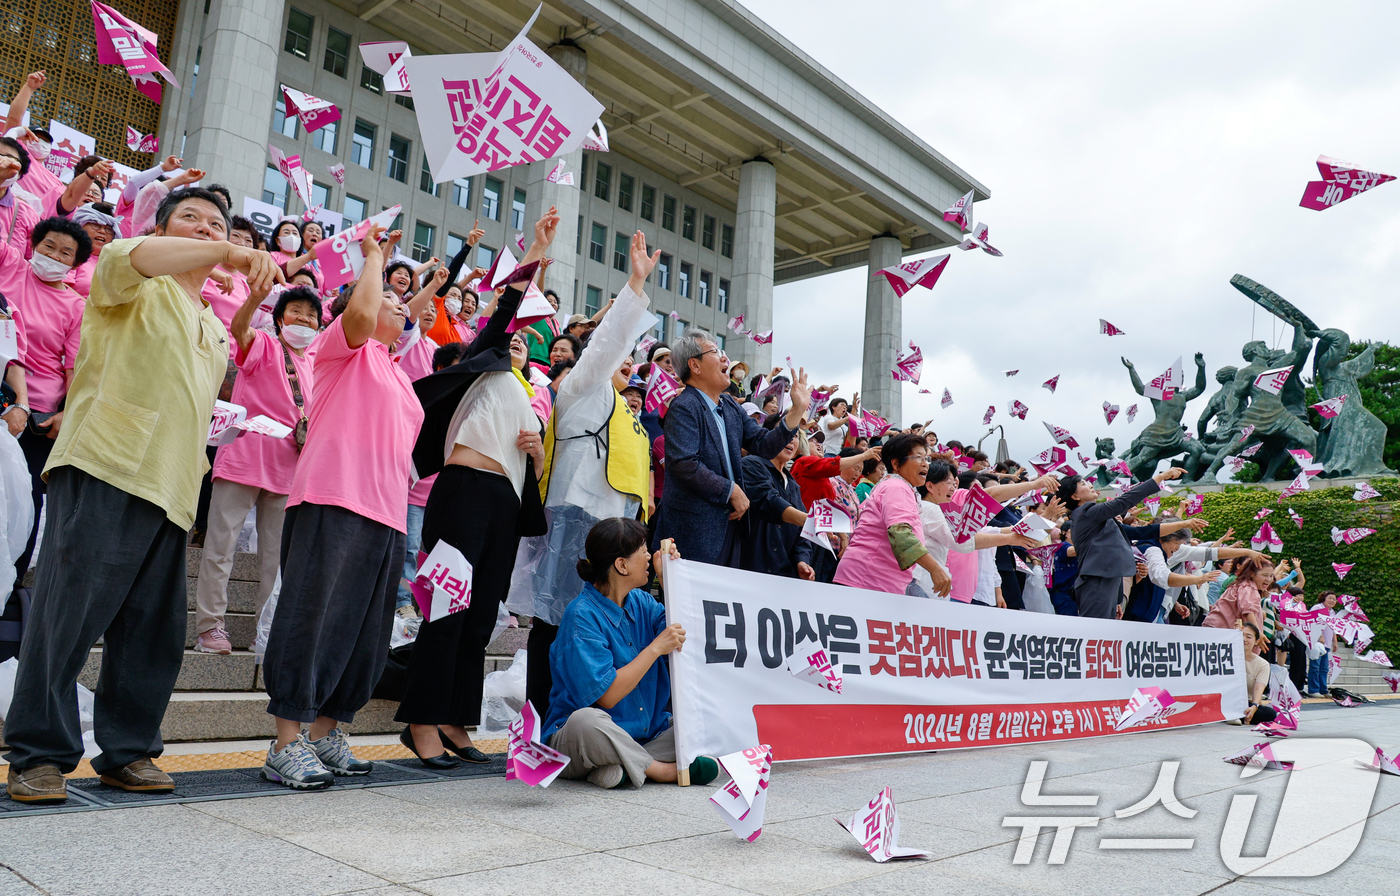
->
[395,463,523,728]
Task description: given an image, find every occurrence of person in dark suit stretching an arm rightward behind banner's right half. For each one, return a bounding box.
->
[1058,466,1186,619]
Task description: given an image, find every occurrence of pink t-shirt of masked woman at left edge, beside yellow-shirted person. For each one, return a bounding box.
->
[0,235,83,413]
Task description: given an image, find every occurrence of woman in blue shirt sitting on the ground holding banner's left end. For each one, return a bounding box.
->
[543,518,720,788]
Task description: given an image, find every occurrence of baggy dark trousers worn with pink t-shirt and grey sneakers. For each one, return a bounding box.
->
[263,504,407,722]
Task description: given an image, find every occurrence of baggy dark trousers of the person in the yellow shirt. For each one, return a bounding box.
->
[4,466,188,773]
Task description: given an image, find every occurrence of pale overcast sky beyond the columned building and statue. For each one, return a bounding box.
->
[748,0,1400,461]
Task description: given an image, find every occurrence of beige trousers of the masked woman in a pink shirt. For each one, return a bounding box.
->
[195,479,287,634]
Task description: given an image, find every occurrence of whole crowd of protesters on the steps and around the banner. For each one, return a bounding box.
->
[0,68,1334,802]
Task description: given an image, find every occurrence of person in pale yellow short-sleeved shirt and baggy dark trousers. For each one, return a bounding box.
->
[4,189,281,804]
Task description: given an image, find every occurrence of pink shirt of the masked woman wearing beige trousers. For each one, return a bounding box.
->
[214,330,315,494]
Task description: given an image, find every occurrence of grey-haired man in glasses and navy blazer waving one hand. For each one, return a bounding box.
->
[655,330,812,567]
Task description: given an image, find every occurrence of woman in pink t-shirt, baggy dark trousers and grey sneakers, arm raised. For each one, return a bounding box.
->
[263,227,420,788]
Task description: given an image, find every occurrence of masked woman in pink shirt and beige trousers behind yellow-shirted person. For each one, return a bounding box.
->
[195,287,321,654]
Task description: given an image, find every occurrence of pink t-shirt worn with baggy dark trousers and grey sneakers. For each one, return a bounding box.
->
[287,318,423,532]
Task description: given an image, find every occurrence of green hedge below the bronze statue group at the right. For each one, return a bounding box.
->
[1162,479,1400,661]
